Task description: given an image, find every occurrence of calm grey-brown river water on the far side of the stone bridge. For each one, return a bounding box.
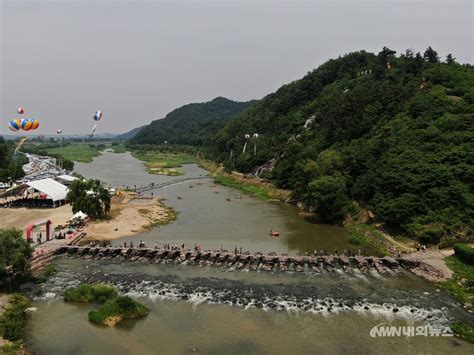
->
[75,152,374,254]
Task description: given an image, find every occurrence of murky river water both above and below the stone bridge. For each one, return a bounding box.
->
[28,153,474,354]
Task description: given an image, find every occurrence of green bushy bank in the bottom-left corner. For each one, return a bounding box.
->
[0,294,30,354]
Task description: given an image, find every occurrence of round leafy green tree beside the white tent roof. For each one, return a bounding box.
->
[67,180,111,218]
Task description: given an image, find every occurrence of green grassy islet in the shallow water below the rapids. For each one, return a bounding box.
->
[64,284,149,326]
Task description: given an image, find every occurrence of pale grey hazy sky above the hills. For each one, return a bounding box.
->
[0,0,474,134]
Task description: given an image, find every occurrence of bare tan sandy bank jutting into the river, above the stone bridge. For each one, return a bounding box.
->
[83,192,176,243]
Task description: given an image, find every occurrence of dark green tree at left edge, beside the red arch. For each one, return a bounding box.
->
[0,229,32,288]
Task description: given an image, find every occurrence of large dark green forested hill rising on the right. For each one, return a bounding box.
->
[209,48,474,240]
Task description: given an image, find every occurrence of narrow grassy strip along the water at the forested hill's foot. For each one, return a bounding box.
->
[199,160,290,201]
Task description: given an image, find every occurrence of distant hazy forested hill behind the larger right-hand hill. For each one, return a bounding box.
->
[131,97,254,146]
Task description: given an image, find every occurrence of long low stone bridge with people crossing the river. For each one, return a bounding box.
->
[54,246,422,274]
